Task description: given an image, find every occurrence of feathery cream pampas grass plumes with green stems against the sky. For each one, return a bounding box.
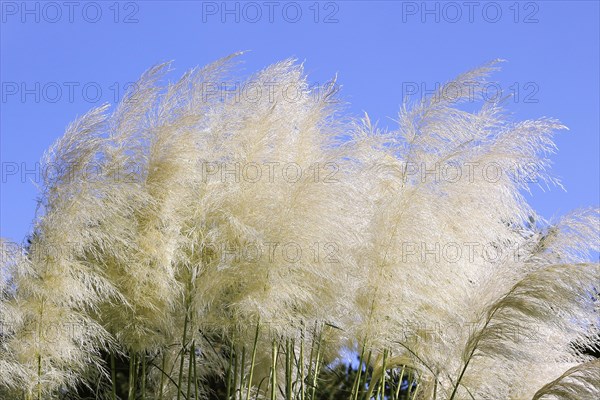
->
[0,54,600,400]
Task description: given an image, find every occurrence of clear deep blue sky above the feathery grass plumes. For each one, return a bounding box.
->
[0,1,600,241]
